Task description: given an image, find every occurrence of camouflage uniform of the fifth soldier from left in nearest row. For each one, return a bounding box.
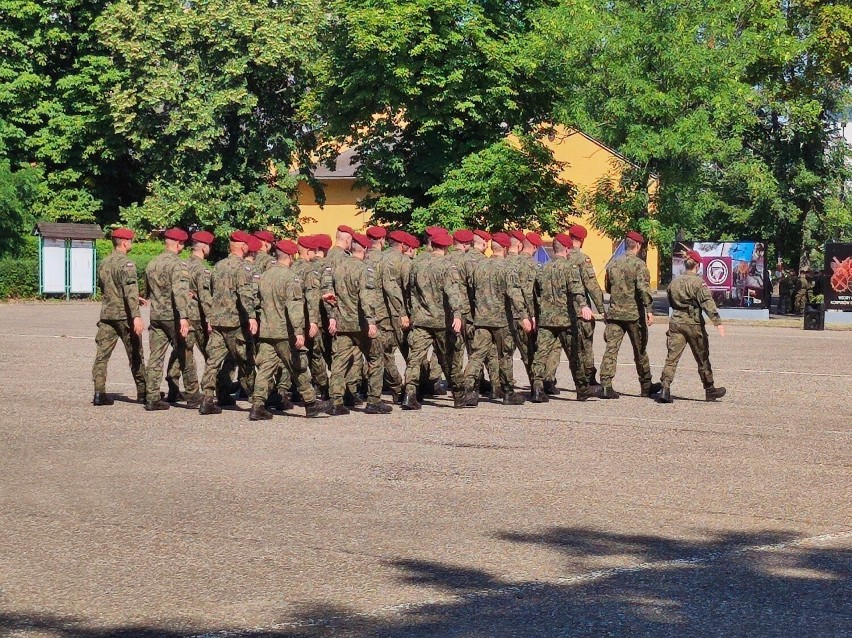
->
[326,253,383,406]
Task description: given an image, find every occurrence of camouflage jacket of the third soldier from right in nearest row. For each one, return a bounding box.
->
[535,257,586,328]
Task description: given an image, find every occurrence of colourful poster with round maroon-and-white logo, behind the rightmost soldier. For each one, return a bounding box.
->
[672,241,770,310]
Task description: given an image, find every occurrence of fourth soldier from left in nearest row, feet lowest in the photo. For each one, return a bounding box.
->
[249,239,329,421]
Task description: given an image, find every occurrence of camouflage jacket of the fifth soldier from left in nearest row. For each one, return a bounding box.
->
[326,257,378,332]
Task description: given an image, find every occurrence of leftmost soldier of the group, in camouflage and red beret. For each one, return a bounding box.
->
[92,228,145,405]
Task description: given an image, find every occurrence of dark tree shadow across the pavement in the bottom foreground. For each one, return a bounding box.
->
[0,527,852,638]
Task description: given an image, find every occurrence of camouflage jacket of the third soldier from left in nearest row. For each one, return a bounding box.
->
[207,255,257,328]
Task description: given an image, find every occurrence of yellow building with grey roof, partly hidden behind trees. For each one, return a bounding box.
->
[299,126,659,288]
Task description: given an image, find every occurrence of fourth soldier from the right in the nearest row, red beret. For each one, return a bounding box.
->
[463,233,532,407]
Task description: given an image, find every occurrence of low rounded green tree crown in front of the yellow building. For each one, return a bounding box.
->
[412,136,574,233]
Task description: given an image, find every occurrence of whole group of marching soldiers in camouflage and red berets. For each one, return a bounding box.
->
[92,225,725,421]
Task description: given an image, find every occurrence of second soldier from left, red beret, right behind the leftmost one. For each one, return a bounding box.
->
[145,228,195,412]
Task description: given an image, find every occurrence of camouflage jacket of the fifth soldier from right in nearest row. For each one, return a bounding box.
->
[409,253,461,330]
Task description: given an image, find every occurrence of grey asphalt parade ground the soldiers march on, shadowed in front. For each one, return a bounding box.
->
[0,302,852,638]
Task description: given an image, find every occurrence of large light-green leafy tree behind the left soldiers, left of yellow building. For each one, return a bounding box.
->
[96,0,320,235]
